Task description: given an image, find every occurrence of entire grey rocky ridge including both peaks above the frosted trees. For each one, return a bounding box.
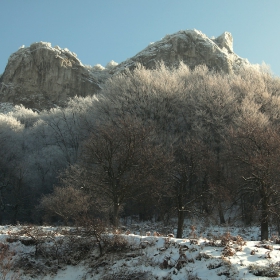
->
[0,30,250,110]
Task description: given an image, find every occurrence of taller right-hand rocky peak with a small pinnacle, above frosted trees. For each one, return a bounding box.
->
[116,30,249,73]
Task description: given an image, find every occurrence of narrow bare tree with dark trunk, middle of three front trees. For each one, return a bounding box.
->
[167,138,209,238]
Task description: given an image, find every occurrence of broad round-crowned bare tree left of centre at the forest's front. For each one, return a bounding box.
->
[80,118,170,226]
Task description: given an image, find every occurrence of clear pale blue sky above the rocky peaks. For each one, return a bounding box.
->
[0,0,280,76]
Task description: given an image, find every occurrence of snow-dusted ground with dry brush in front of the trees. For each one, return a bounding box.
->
[0,223,280,280]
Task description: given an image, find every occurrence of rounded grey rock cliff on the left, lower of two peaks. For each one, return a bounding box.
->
[0,42,100,109]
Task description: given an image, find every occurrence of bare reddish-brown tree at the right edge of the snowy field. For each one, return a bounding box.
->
[232,121,280,240]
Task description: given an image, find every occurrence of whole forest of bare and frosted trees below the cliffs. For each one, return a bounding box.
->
[0,63,280,239]
